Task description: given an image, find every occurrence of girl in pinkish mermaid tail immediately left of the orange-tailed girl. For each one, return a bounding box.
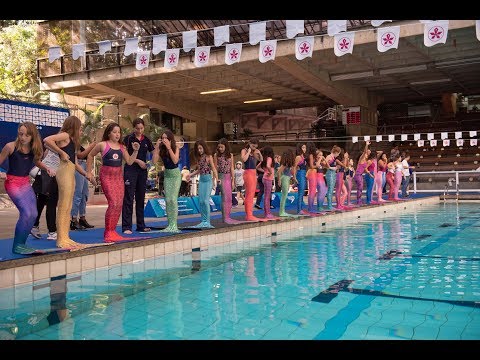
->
[213,138,240,224]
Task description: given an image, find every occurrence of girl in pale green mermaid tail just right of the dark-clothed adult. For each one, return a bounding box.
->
[152,130,182,233]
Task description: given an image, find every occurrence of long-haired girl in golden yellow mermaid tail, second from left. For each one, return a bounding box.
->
[43,116,95,248]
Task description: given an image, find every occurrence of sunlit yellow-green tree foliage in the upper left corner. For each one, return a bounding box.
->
[0,20,40,97]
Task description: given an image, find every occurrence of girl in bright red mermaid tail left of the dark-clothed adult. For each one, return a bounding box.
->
[87,123,140,243]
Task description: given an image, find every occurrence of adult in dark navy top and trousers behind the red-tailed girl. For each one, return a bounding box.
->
[122,118,153,234]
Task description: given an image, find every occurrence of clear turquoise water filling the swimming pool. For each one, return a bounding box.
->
[0,203,480,340]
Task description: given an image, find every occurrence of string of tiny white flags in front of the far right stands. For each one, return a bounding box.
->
[352,130,477,147]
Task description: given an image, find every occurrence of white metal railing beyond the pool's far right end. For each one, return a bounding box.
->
[412,170,480,195]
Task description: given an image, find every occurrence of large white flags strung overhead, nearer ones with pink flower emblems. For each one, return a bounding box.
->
[48,20,480,70]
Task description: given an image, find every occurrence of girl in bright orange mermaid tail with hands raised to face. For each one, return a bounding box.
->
[240,138,264,221]
